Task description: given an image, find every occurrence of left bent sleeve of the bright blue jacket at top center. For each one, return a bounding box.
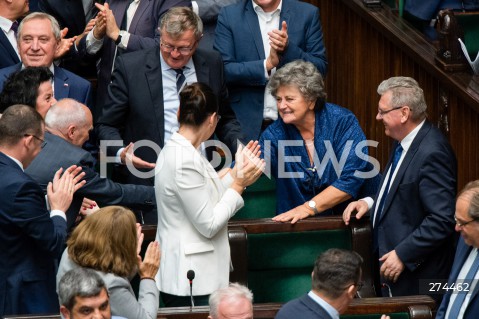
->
[214,8,267,86]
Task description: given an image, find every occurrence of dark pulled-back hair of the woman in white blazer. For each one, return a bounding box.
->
[178,83,218,126]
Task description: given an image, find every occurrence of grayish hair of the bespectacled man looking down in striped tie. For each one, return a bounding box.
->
[159,7,203,41]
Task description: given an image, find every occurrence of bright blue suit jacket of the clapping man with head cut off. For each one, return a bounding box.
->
[214,0,327,140]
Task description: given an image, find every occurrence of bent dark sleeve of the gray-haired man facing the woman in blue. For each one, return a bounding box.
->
[395,146,456,271]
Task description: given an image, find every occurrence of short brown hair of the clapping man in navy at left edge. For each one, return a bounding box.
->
[0,104,44,146]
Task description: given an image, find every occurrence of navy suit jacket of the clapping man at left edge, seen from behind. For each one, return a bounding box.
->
[0,152,67,316]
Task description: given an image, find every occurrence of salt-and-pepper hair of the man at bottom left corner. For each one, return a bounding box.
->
[58,267,108,311]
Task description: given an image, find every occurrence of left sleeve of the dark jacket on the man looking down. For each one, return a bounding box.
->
[96,56,129,156]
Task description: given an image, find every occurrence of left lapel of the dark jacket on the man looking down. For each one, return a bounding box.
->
[145,48,165,147]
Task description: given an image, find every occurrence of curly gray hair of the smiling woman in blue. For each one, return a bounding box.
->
[268,60,326,110]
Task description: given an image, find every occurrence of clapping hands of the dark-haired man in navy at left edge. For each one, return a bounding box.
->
[47,165,86,212]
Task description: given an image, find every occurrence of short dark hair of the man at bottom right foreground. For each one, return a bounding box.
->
[312,248,363,299]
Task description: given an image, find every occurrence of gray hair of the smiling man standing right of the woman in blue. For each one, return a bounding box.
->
[378,76,427,121]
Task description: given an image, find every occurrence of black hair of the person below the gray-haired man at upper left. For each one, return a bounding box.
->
[0,67,53,113]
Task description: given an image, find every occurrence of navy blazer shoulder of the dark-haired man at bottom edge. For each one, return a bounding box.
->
[274,294,333,319]
